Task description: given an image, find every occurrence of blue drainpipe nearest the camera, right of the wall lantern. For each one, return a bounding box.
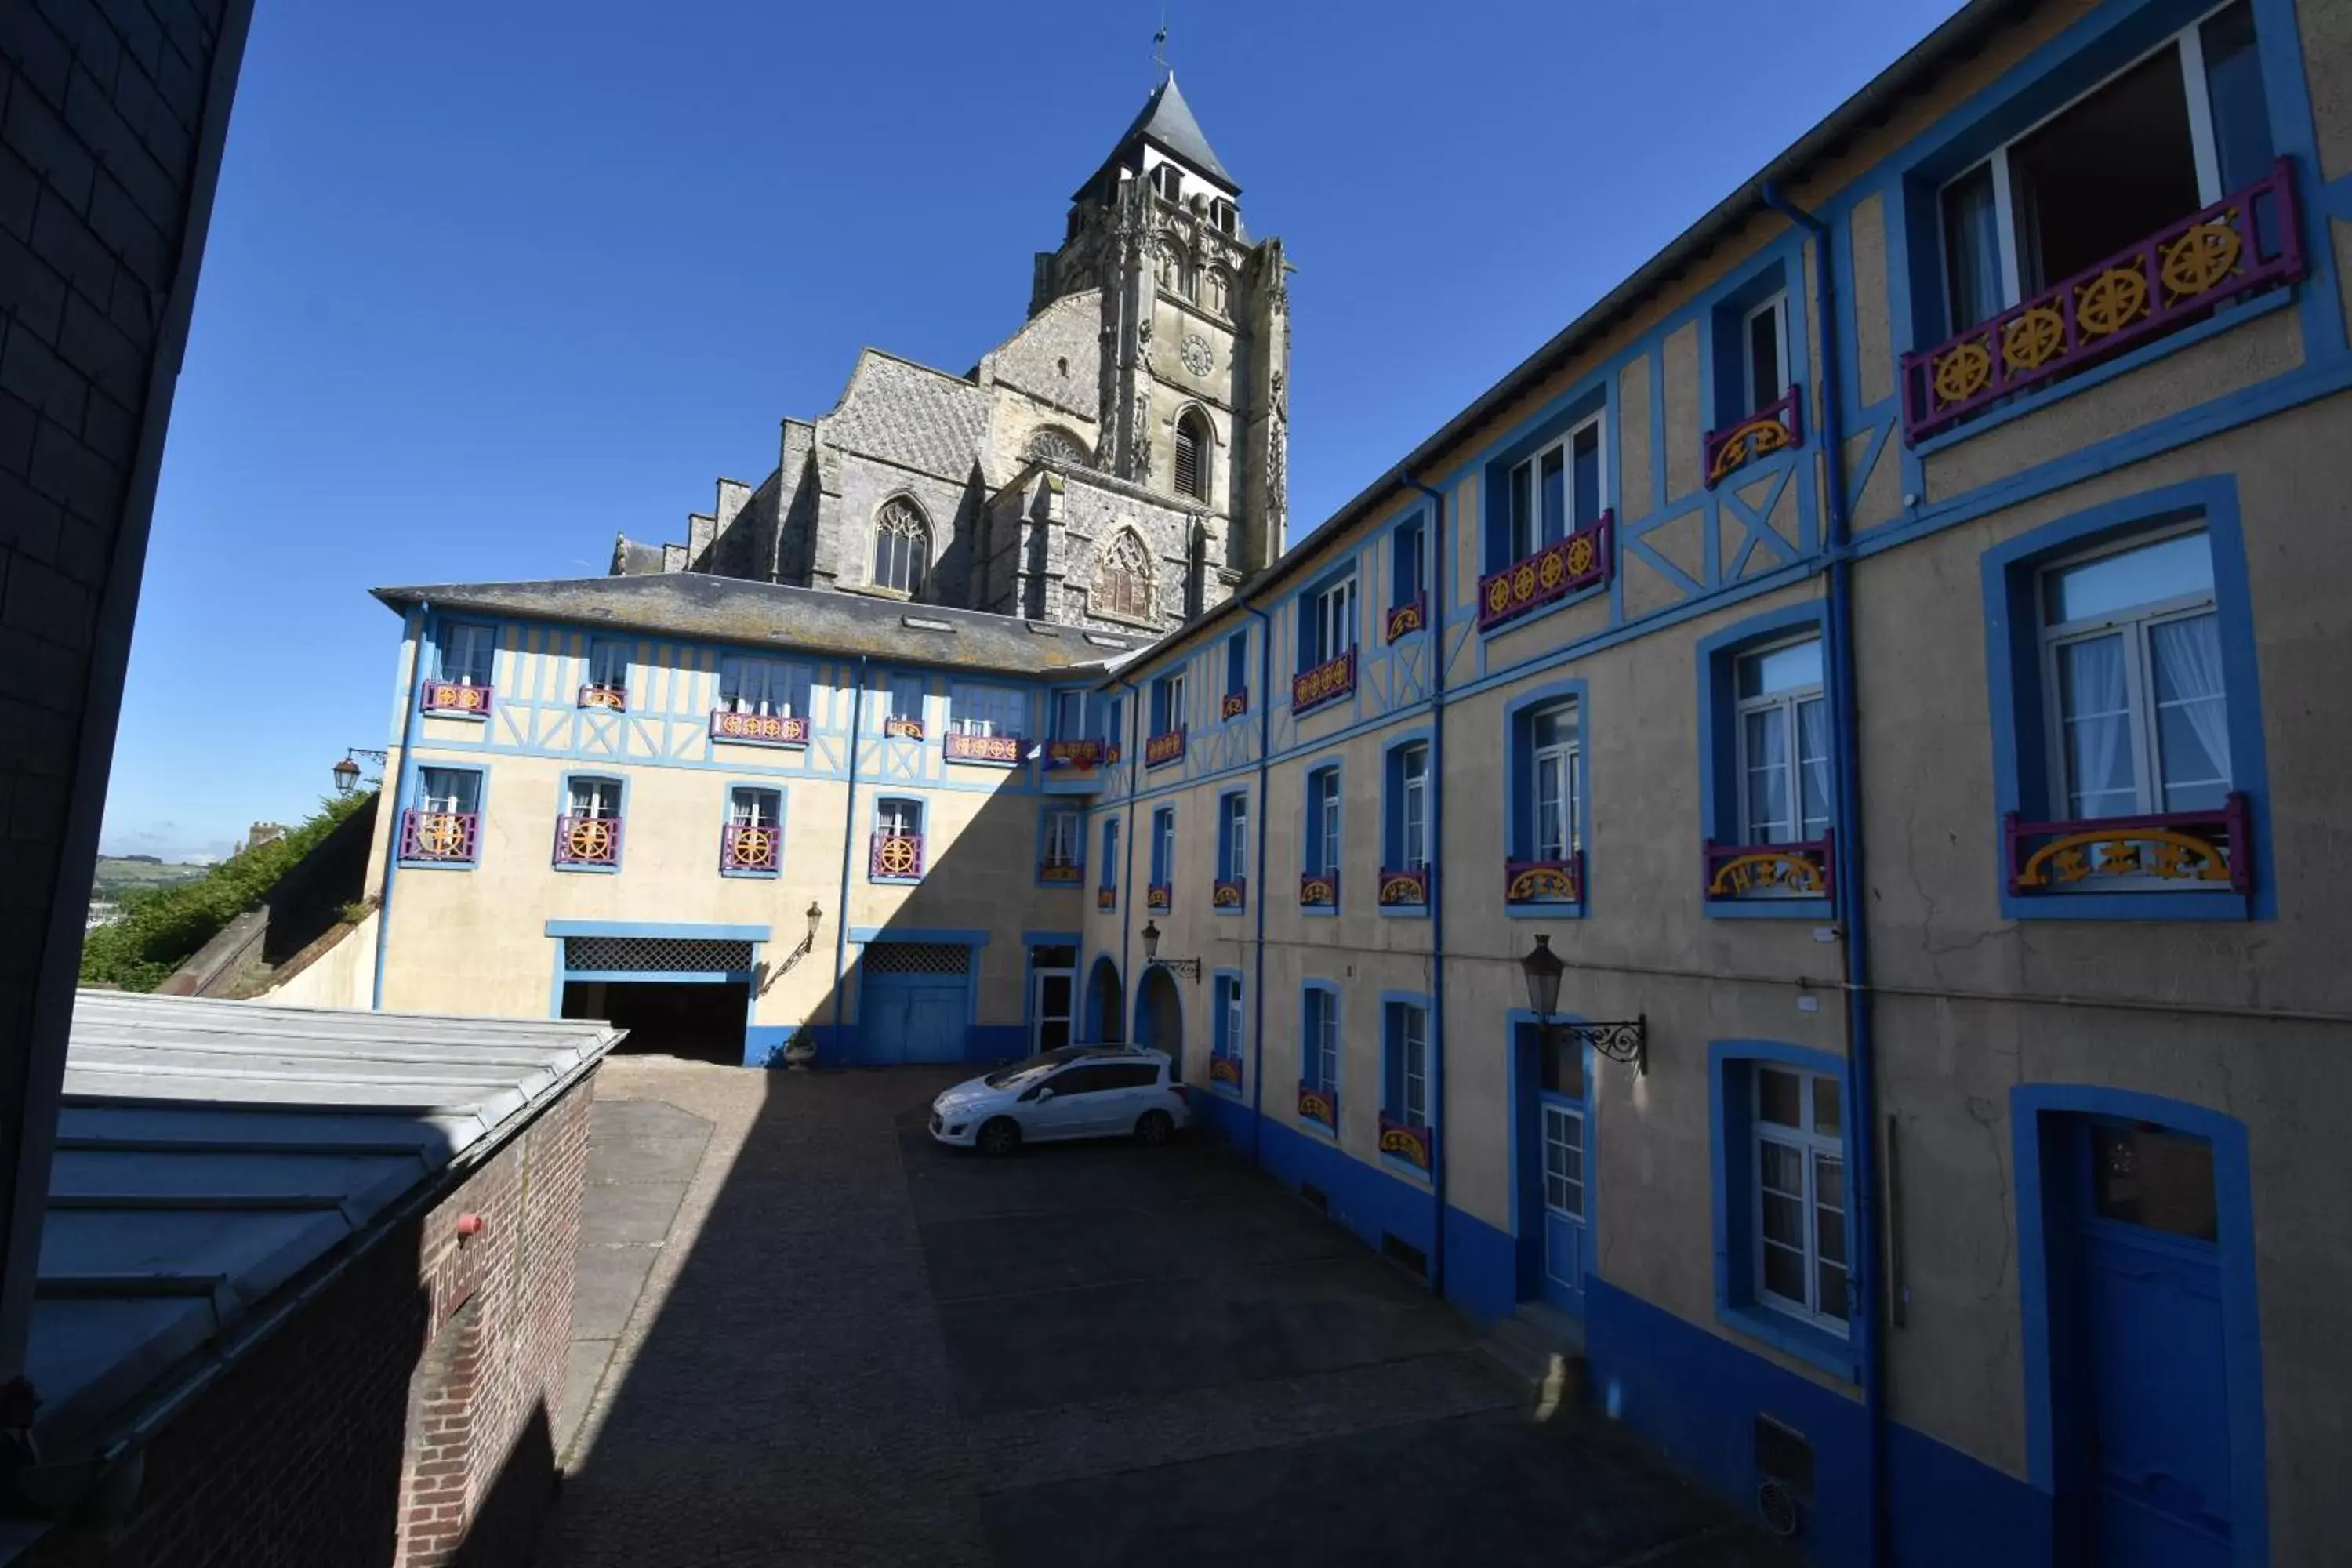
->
[1757,181,1889,1566]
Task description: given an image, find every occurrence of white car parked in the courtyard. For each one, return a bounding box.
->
[931,1046,1190,1154]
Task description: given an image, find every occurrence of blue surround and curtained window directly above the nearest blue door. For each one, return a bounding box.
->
[1983,477,2277,919]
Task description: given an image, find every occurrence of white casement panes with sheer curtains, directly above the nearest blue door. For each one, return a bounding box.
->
[2042,529,2230,820]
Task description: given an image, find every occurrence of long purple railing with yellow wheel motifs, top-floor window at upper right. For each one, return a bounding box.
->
[1903,158,2305,445]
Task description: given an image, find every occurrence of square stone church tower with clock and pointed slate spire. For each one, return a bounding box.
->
[1030,71,1291,587]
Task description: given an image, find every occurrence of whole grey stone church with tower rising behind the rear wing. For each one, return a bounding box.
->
[612,73,1291,633]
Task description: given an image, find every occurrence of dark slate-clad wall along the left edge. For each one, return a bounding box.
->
[0,0,252,1377]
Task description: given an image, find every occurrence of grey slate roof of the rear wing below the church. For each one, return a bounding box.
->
[374,572,1150,677]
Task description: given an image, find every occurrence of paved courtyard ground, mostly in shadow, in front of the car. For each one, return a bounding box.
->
[541,1058,1792,1568]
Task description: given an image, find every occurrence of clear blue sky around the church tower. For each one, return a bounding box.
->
[103,0,1955,858]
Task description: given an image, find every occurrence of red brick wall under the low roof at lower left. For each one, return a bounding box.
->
[24,1074,595,1568]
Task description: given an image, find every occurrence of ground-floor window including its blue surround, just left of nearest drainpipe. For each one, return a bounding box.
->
[1708,1039,1860,1377]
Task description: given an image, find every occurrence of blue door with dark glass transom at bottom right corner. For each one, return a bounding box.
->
[2070,1119,2237,1568]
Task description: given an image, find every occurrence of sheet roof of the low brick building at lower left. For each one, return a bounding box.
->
[26,992,621,1460]
